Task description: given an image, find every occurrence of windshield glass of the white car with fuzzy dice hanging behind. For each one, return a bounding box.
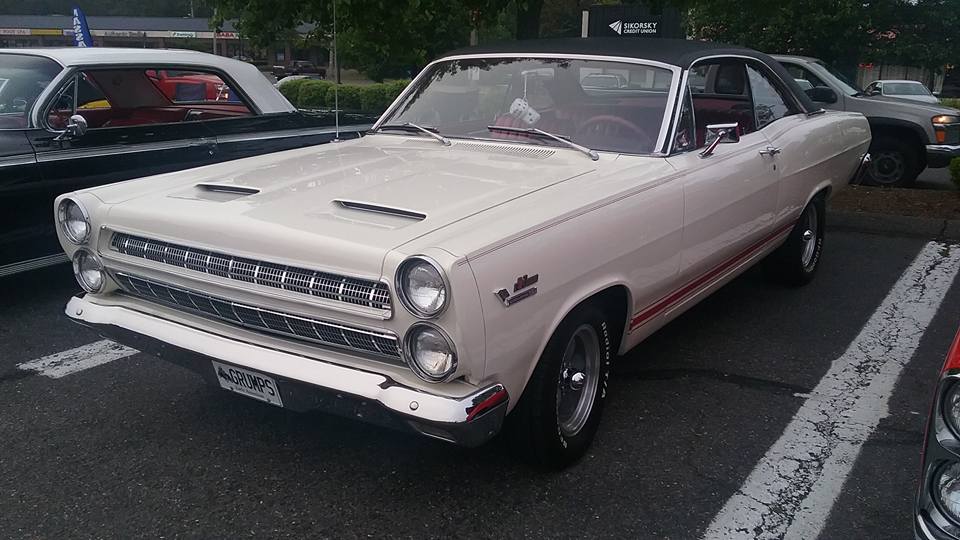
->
[383,58,673,154]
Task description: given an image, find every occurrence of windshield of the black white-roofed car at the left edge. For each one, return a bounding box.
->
[0,54,62,129]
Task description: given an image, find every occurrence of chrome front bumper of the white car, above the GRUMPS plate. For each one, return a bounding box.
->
[66,296,509,446]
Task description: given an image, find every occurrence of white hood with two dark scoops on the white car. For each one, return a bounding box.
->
[99,135,600,277]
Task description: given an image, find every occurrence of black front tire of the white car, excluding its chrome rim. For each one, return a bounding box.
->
[504,305,615,470]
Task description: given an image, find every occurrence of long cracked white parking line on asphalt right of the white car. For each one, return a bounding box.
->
[704,242,960,540]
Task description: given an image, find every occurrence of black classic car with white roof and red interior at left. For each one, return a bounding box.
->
[0,48,375,277]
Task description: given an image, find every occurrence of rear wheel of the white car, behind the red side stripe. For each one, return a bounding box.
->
[767,195,826,287]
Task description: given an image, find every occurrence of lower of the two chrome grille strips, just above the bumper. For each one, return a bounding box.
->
[114,273,401,362]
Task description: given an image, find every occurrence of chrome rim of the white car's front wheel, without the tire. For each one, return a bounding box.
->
[557,324,600,437]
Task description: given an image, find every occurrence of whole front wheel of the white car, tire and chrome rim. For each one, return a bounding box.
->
[506,306,614,469]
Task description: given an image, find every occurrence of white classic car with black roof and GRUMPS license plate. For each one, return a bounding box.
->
[55,39,870,467]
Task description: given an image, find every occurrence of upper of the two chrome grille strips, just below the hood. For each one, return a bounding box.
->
[110,233,391,310]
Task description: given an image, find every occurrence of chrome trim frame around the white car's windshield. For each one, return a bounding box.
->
[370,52,683,157]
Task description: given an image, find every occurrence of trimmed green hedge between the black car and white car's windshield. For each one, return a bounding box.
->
[280,79,410,113]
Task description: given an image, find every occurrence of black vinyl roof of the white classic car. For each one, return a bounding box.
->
[443,37,818,111]
